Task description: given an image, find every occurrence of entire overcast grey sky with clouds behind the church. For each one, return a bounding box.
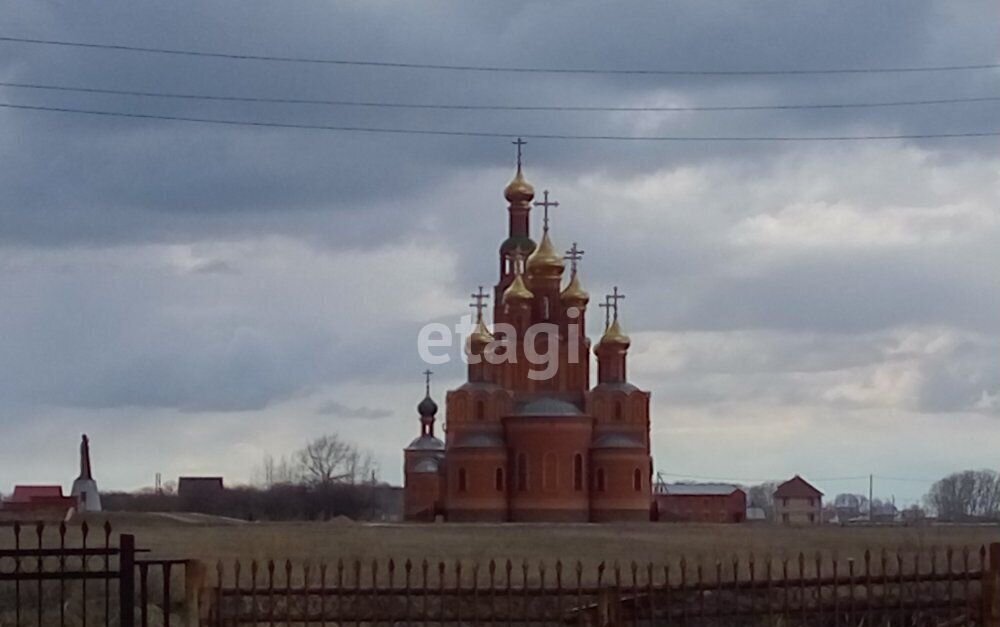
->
[0,0,1000,504]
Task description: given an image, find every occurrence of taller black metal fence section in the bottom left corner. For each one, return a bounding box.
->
[0,522,187,627]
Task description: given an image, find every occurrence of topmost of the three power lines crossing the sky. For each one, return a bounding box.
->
[0,36,1000,76]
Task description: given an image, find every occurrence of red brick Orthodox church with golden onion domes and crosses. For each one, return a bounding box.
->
[404,145,653,522]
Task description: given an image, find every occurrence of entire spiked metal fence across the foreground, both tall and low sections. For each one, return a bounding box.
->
[0,523,1000,627]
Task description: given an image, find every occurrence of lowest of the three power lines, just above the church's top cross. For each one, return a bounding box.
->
[7,103,1000,142]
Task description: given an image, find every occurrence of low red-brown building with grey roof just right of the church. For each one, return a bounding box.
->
[653,483,747,523]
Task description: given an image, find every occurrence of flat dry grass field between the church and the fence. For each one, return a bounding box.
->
[45,514,1000,565]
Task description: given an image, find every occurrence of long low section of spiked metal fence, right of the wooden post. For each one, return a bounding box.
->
[209,545,1000,627]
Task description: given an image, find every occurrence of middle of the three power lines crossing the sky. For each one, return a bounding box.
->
[0,81,1000,113]
